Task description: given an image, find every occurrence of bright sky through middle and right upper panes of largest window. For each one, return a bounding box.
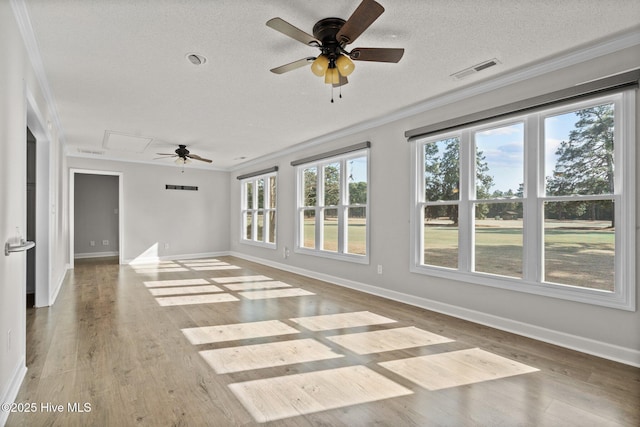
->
[476,113,578,193]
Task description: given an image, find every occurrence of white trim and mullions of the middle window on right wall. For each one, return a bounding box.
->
[293,148,371,264]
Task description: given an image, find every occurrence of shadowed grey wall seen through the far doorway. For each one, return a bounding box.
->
[70,173,120,258]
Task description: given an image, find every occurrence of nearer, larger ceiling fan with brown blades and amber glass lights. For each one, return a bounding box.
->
[267,0,404,89]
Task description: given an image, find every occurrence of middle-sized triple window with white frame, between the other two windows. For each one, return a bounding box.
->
[296,150,369,263]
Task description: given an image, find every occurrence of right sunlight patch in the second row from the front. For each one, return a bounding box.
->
[327,326,453,354]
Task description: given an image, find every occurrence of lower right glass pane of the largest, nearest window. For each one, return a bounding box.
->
[544,200,615,291]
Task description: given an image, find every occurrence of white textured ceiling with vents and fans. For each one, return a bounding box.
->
[23,0,640,169]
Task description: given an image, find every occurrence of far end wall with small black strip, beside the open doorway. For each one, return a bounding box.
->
[68,157,229,262]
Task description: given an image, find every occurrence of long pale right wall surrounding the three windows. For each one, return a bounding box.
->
[230,45,640,366]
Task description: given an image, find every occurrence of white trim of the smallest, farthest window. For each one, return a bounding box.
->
[240,172,278,249]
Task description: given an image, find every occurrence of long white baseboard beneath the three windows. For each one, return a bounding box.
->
[230,252,640,367]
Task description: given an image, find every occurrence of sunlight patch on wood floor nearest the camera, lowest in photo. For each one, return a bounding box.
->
[229,366,413,422]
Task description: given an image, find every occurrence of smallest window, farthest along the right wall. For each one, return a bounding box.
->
[241,173,276,247]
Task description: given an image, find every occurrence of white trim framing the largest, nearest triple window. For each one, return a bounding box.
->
[410,90,636,311]
